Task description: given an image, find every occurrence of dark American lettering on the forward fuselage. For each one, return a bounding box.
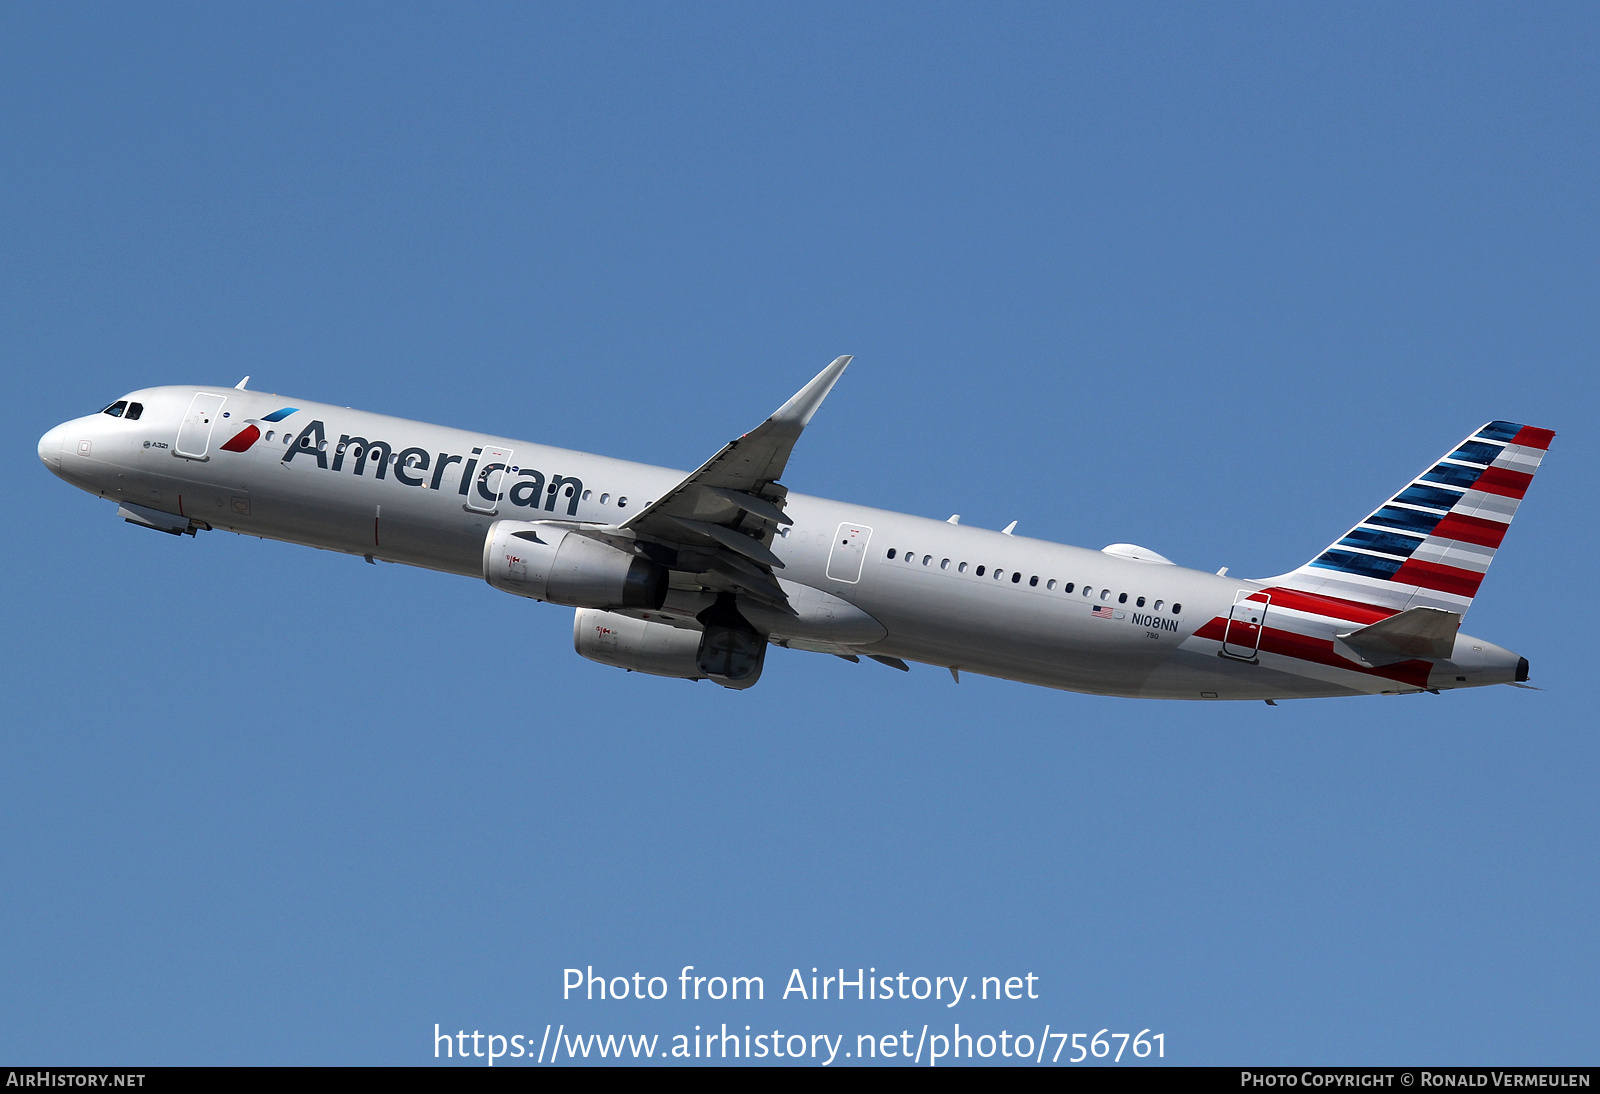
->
[276,419,584,517]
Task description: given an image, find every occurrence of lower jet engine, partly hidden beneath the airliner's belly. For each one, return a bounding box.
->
[573,608,766,691]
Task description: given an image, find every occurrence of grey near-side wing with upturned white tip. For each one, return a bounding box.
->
[621,355,850,609]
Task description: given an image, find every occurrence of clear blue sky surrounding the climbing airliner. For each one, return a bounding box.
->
[0,5,1600,1064]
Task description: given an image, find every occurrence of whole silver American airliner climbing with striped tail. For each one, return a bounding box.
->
[38,357,1554,704]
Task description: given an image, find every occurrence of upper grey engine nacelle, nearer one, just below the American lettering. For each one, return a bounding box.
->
[483,520,669,609]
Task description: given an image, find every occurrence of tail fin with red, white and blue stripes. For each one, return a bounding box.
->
[1272,422,1555,614]
